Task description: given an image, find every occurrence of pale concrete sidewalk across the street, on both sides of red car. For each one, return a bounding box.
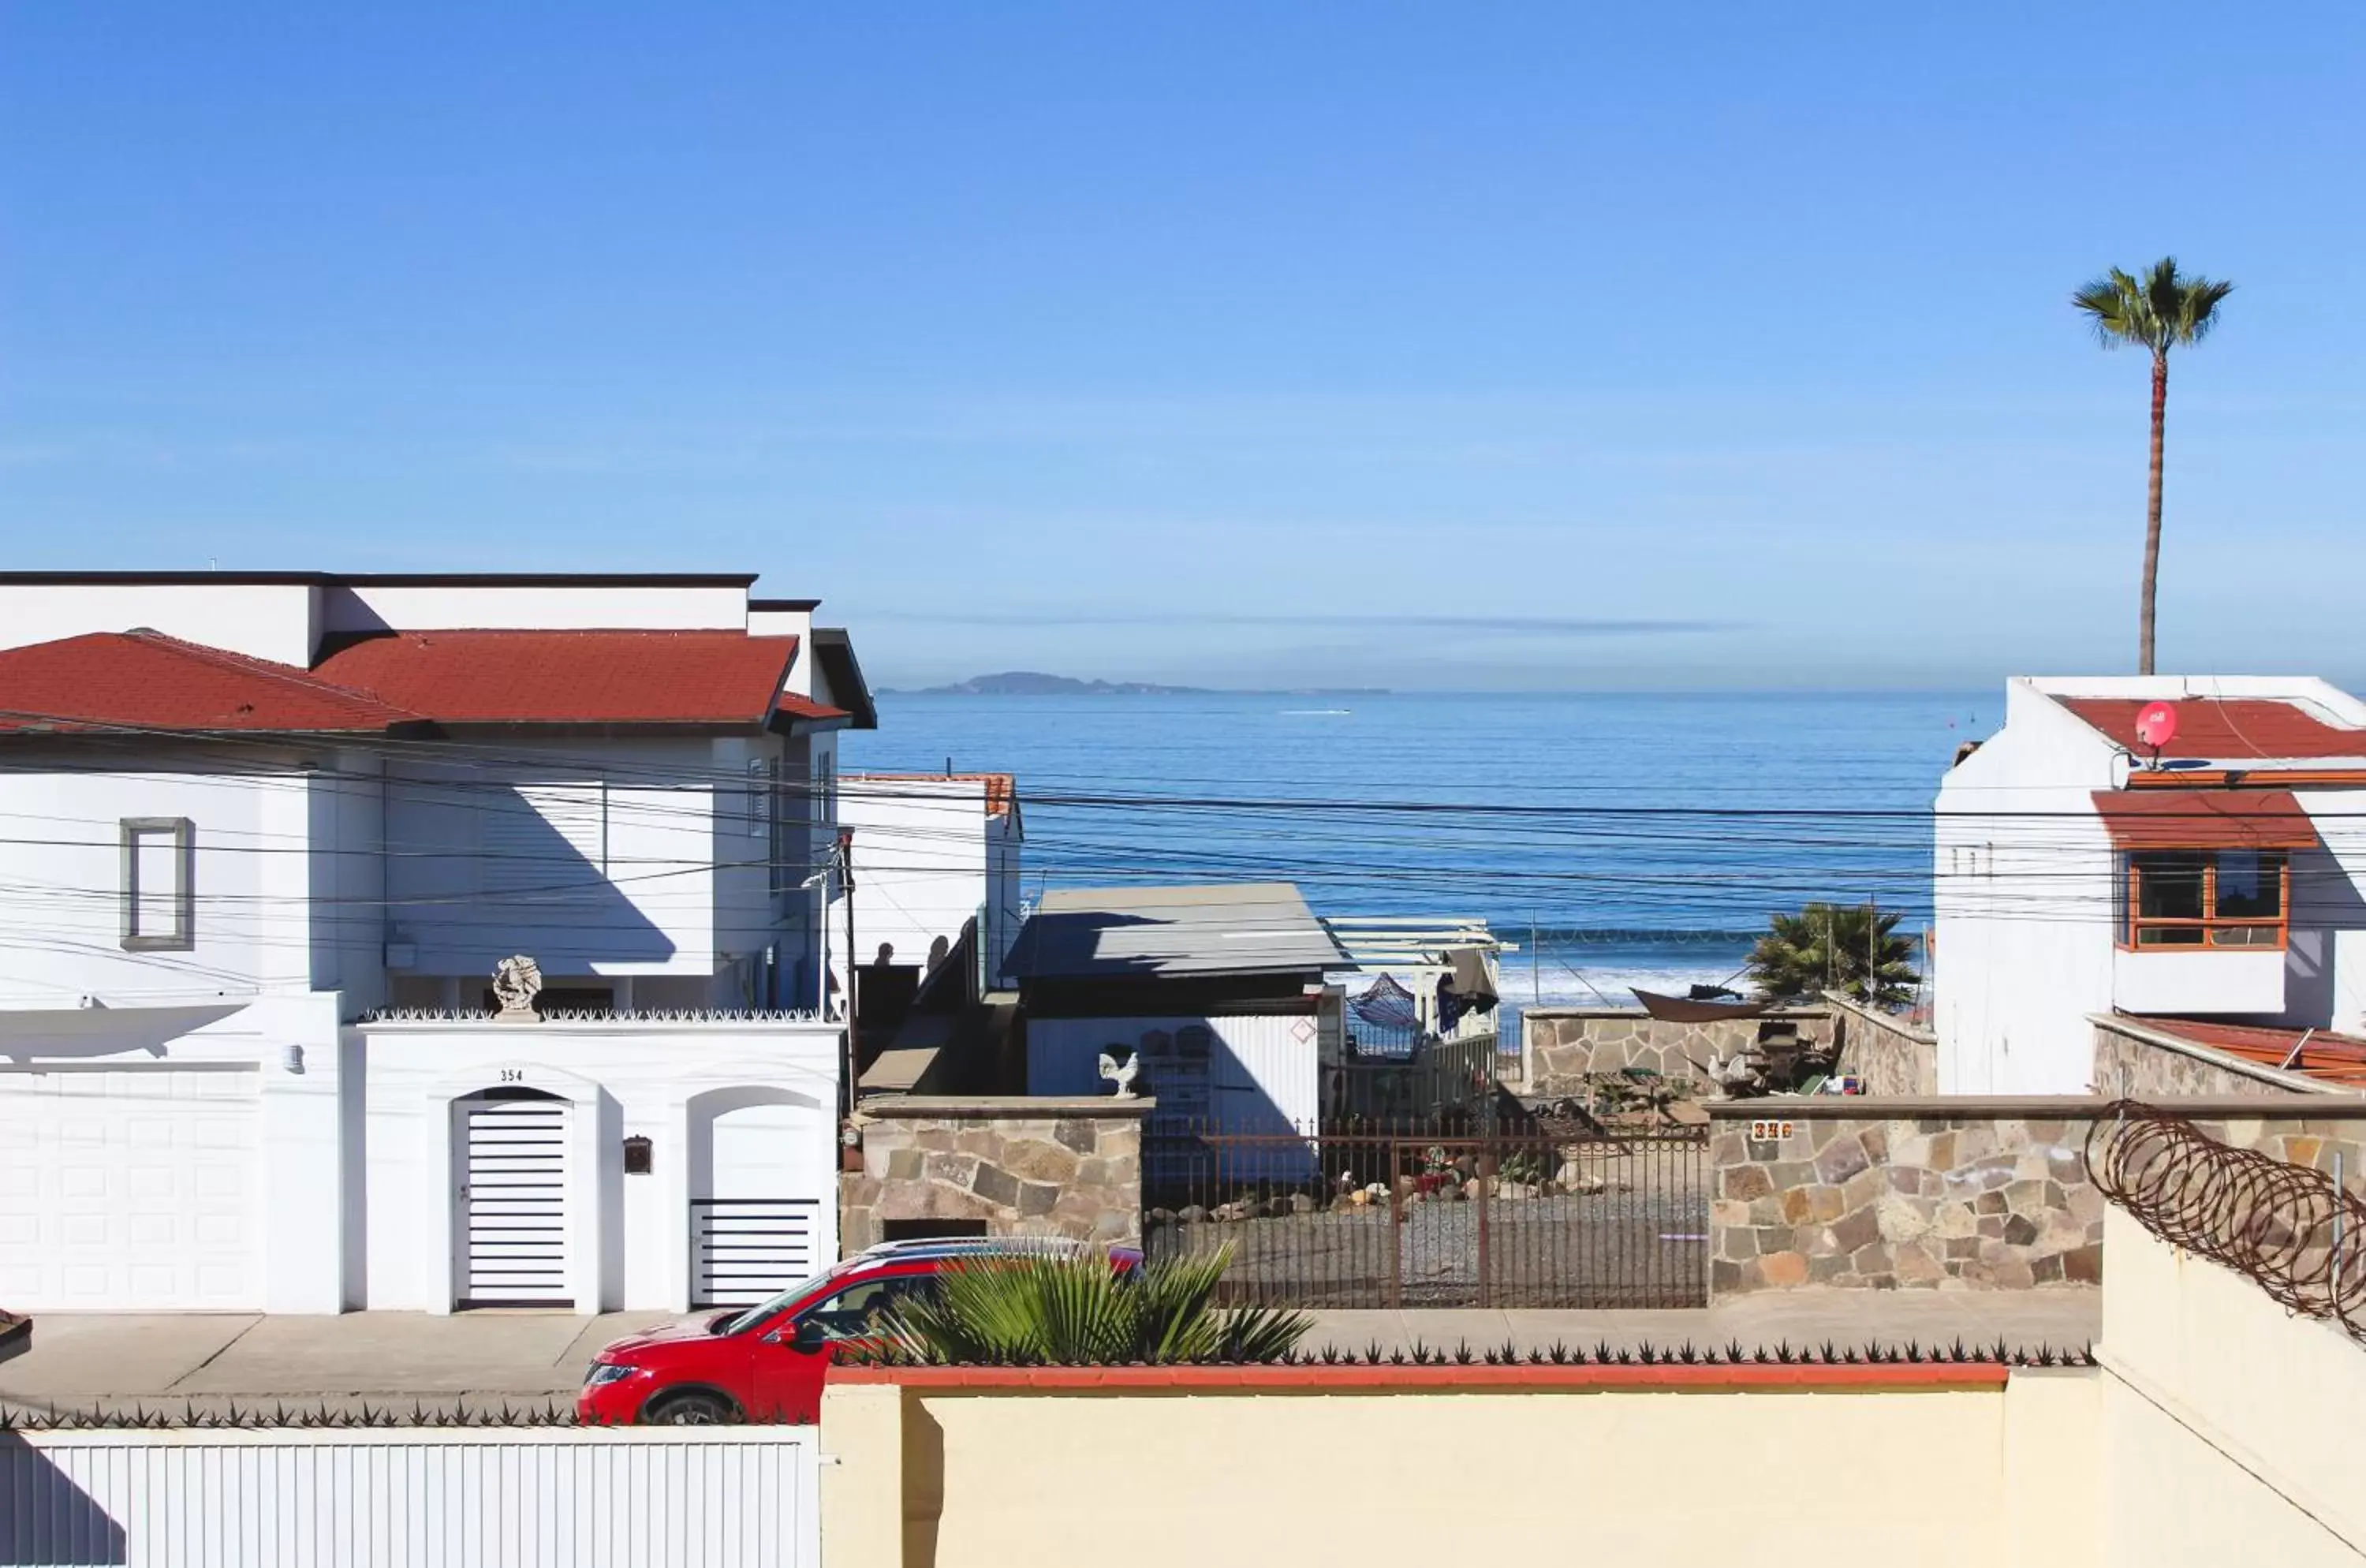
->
[0,1286,2101,1412]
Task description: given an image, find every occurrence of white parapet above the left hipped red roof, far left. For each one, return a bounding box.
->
[0,582,319,670]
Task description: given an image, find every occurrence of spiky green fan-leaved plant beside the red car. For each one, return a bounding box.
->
[887,1246,1313,1367]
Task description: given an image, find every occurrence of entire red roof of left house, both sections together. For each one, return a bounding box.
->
[0,632,847,734]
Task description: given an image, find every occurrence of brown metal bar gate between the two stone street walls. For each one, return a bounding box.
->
[1143,1126,1708,1308]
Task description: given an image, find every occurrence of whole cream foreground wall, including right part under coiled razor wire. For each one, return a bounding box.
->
[821,1211,2366,1568]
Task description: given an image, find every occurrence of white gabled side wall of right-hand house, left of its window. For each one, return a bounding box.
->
[1933,681,2115,1095]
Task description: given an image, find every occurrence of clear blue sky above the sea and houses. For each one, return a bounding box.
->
[0,2,2366,689]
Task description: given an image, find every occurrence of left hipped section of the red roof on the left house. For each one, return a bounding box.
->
[0,632,419,734]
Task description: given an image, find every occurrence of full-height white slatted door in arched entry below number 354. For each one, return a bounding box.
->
[452,1088,575,1308]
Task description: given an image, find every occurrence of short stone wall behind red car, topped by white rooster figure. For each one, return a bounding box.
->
[838,1095,1155,1253]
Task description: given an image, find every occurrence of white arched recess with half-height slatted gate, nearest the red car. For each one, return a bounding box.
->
[691,1102,838,1308]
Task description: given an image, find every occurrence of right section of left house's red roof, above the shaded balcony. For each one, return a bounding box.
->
[312,632,797,724]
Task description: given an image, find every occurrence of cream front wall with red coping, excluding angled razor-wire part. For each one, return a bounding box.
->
[821,1367,2101,1568]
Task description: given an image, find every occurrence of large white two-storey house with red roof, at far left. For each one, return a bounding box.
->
[0,573,871,1312]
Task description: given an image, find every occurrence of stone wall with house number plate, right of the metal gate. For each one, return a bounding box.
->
[1708,1095,2366,1294]
